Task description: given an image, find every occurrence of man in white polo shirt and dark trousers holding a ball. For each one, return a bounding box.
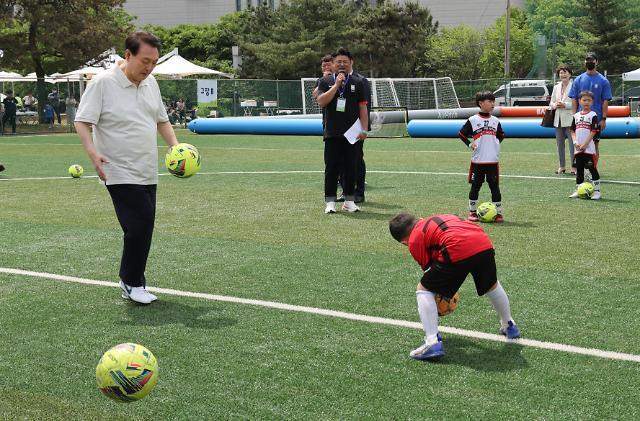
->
[75,32,178,304]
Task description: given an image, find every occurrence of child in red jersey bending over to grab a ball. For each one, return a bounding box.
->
[389,213,520,360]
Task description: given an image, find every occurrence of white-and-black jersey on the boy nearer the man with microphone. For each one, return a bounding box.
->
[459,113,504,164]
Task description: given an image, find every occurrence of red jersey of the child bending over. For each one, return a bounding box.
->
[408,214,493,270]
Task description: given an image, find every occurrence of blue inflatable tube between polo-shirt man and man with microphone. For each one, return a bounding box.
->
[187,117,322,136]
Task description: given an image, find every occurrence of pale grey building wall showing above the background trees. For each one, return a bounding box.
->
[124,0,524,29]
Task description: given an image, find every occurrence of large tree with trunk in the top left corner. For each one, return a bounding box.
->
[0,0,132,118]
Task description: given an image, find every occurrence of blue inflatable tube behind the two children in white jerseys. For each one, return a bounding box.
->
[407,117,640,139]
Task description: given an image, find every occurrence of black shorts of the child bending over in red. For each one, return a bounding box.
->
[420,249,498,297]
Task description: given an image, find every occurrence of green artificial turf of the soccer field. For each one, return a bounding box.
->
[0,131,640,420]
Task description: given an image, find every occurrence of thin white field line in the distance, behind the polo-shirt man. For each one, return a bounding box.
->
[0,170,640,186]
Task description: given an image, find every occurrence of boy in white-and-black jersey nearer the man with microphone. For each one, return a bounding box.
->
[459,91,504,222]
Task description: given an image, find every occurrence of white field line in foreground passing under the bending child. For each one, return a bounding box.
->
[0,268,640,363]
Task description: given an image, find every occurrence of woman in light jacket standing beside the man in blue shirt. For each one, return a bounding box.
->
[549,64,576,174]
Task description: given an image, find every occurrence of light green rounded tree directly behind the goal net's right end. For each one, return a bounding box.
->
[419,25,484,80]
